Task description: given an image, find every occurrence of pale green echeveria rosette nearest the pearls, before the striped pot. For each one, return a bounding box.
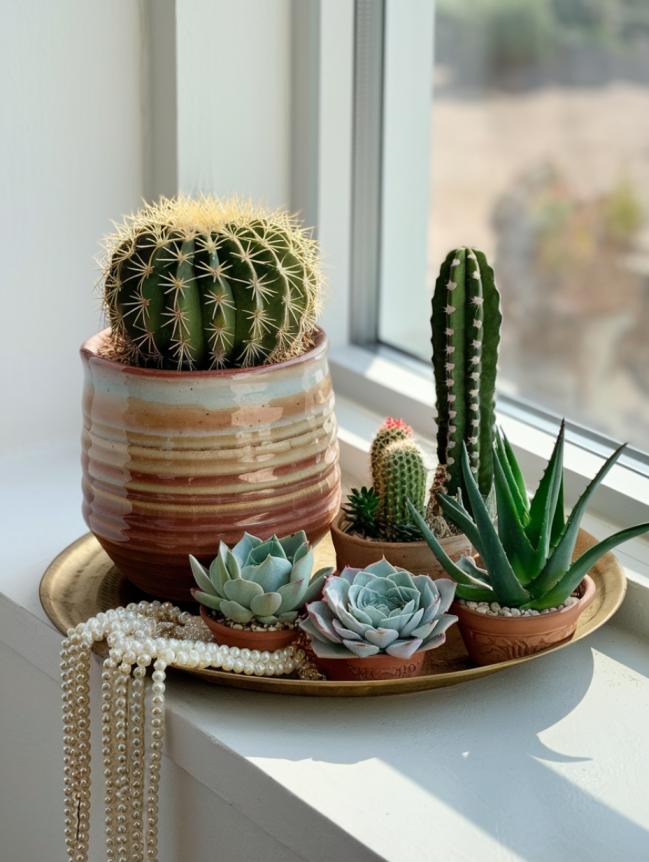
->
[189,530,333,625]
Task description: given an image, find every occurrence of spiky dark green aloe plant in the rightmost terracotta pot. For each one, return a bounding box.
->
[410,422,649,611]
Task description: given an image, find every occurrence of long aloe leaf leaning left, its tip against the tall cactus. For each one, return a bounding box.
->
[462,444,529,607]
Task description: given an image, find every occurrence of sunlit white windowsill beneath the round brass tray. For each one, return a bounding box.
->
[0,442,649,862]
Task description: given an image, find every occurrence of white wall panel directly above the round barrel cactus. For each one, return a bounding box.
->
[176,0,291,207]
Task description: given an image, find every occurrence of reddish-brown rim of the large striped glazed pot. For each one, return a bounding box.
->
[79,326,328,380]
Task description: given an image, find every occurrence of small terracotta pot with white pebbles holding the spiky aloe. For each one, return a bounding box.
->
[451,575,595,665]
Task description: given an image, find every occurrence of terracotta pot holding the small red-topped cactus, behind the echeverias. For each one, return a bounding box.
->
[331,513,473,578]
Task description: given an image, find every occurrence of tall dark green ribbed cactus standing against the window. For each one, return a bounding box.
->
[431,248,502,497]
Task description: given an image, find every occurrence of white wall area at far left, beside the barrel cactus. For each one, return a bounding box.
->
[0,0,143,449]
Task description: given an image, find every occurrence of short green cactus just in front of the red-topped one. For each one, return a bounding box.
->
[380,439,426,540]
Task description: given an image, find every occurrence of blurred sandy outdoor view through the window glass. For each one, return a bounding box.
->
[381,0,649,451]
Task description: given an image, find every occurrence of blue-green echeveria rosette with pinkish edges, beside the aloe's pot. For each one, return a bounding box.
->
[300,559,457,659]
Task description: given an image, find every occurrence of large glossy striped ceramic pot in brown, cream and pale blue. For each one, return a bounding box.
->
[81,330,340,601]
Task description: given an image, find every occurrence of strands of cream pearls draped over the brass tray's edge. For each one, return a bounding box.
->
[61,602,306,862]
